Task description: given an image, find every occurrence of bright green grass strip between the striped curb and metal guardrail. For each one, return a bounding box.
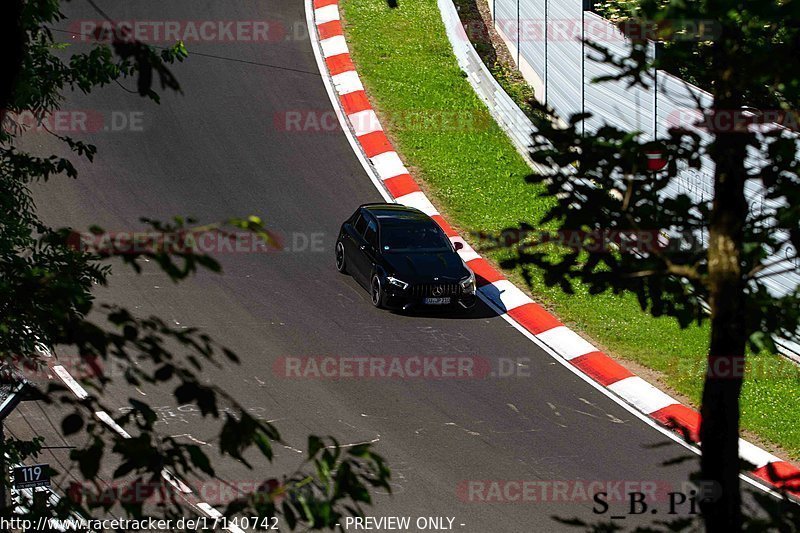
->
[343,0,800,459]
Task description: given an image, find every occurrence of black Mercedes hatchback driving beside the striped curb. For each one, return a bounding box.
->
[336,204,476,310]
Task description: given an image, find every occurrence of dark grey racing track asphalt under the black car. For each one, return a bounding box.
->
[10,0,764,532]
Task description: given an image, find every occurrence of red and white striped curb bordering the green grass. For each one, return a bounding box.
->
[306,0,800,497]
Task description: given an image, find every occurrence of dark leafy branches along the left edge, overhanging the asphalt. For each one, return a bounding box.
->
[0,0,390,529]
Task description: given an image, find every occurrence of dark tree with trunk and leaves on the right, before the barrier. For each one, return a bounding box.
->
[505,0,800,531]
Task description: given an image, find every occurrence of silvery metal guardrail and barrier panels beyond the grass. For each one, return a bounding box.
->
[438,0,800,363]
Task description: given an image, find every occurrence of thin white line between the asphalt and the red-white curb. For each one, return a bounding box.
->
[305,0,781,497]
